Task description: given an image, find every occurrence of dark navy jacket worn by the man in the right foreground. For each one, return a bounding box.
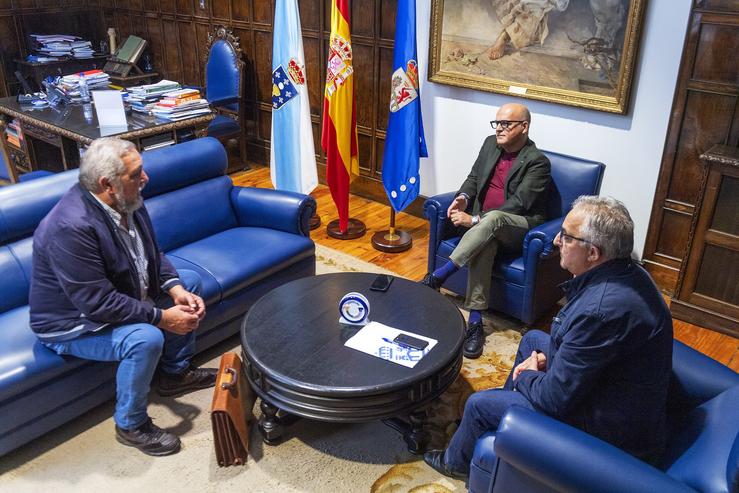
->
[514,259,672,459]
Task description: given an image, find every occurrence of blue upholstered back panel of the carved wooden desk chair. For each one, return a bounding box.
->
[205,39,240,111]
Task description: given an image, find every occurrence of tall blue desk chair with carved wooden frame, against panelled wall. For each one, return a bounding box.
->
[205,26,249,172]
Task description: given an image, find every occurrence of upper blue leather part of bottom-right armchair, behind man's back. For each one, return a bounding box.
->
[670,340,739,410]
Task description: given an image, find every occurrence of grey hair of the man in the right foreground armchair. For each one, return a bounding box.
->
[572,195,634,259]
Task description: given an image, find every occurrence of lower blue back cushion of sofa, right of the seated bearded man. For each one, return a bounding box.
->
[144,176,237,252]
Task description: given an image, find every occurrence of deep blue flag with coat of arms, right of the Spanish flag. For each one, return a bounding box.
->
[382,0,428,211]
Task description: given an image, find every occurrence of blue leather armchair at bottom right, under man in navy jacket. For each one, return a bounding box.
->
[469,341,739,493]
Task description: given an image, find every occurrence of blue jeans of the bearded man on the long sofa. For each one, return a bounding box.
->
[45,270,202,430]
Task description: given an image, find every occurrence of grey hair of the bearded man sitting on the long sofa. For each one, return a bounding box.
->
[79,137,136,193]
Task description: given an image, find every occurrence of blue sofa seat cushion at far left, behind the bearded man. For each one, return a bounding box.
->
[0,305,87,401]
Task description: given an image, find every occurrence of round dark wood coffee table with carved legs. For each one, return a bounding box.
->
[241,273,465,453]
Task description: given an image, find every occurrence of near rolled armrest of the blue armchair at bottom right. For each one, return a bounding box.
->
[495,406,695,493]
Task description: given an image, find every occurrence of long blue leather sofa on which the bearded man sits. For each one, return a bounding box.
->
[0,138,316,455]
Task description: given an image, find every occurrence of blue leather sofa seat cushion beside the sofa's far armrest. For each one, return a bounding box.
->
[167,228,315,299]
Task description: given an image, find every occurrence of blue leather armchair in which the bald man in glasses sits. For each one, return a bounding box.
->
[424,151,605,324]
